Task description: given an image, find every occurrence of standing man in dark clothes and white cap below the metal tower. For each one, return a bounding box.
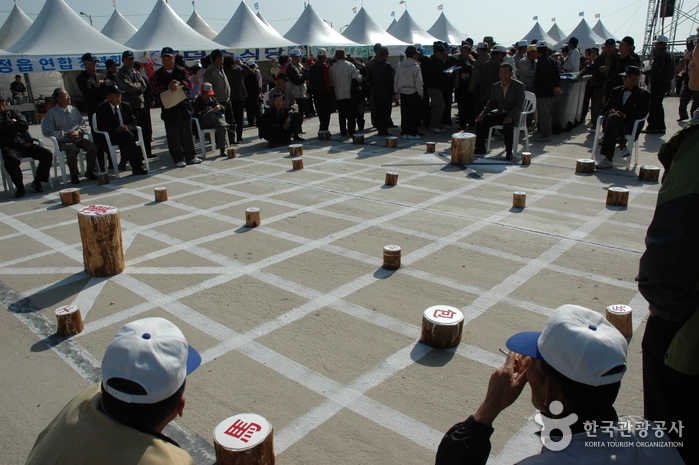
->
[643,36,675,134]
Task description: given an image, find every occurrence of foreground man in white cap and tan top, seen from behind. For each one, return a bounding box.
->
[27,318,201,465]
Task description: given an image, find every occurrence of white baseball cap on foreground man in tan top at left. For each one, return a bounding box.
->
[102,318,201,404]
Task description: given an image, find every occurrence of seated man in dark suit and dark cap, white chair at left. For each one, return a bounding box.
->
[95,86,148,175]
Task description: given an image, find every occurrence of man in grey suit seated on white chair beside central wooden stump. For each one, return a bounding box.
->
[475,63,524,160]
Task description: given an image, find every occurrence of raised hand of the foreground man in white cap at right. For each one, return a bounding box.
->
[475,351,532,426]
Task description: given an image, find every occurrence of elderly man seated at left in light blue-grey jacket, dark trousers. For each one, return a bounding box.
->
[41,87,100,184]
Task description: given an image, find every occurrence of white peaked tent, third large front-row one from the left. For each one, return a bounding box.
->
[219,2,295,48]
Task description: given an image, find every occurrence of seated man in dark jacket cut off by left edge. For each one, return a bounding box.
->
[0,92,53,198]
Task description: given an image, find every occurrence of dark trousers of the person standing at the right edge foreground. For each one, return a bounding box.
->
[641,316,699,464]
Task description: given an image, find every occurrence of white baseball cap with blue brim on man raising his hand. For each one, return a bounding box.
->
[506,305,628,386]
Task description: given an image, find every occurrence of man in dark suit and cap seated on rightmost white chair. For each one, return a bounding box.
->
[597,66,651,169]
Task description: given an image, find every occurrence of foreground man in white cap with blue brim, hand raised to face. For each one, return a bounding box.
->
[435,305,684,465]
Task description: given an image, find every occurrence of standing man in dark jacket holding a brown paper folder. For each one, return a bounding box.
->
[150,47,201,168]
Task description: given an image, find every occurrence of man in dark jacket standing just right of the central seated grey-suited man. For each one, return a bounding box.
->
[534,41,563,142]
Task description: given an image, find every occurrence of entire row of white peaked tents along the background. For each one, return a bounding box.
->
[0,0,624,57]
